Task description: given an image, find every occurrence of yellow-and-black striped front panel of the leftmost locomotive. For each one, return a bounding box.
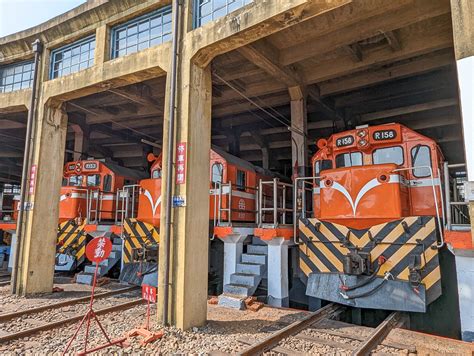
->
[56,220,87,265]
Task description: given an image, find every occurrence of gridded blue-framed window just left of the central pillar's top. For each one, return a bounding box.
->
[110,5,173,59]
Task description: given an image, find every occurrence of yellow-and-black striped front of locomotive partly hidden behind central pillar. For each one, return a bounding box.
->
[123,219,160,263]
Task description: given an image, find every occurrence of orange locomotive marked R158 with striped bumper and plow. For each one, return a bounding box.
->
[295,124,444,312]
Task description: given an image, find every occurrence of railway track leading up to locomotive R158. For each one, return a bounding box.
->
[238,304,416,356]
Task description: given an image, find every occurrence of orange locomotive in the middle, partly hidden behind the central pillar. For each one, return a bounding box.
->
[121,147,271,283]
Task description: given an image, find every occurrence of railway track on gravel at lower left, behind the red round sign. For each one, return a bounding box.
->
[0,287,143,344]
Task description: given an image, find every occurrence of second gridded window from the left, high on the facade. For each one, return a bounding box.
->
[50,36,95,79]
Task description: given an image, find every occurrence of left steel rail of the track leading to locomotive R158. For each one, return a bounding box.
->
[237,303,343,356]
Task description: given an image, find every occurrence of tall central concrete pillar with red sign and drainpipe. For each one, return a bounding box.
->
[158,60,212,329]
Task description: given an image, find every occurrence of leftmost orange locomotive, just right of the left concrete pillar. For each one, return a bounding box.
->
[56,160,144,271]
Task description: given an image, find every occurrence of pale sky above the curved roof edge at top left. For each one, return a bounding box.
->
[0,0,86,37]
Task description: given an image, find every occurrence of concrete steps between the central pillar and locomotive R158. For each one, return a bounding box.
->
[219,244,268,310]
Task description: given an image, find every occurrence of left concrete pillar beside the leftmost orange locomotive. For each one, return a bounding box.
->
[16,102,67,295]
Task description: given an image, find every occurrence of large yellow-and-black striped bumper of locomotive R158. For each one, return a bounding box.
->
[298,216,441,310]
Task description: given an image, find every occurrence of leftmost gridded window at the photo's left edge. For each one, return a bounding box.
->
[0,61,33,93]
